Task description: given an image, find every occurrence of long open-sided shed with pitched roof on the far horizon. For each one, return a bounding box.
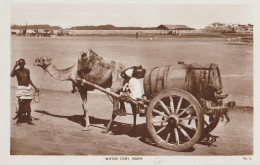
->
[156,24,195,35]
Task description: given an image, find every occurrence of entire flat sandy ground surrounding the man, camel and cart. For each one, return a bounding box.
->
[8,37,254,156]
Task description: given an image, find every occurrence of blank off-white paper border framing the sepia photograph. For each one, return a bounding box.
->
[0,0,260,165]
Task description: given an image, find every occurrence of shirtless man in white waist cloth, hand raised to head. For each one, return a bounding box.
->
[11,58,39,125]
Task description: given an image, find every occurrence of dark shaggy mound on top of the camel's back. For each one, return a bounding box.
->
[78,49,97,73]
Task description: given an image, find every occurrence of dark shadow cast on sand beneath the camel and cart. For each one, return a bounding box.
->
[35,110,219,152]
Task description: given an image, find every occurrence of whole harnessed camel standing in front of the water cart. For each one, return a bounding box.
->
[34,49,137,133]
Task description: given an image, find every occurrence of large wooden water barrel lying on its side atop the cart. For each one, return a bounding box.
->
[143,64,222,98]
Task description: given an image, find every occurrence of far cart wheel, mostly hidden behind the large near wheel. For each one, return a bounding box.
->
[203,112,220,135]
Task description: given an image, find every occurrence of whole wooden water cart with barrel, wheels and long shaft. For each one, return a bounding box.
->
[78,63,235,151]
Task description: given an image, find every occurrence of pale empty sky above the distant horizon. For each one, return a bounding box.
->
[10,3,254,29]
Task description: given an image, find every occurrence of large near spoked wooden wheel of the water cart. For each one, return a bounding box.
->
[146,89,204,151]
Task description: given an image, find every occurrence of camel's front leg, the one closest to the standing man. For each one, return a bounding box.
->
[78,87,90,131]
